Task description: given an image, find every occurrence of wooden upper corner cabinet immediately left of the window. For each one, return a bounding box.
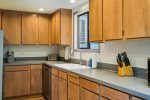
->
[50,9,72,45]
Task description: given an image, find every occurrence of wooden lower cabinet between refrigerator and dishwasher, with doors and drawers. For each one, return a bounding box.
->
[4,65,42,98]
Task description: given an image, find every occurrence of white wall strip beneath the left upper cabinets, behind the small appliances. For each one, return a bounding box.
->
[4,45,59,57]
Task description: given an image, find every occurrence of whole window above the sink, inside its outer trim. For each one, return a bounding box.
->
[74,12,99,51]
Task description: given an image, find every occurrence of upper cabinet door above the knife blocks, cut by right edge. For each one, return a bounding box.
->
[123,0,150,38]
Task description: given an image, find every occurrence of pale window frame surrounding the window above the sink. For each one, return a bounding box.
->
[72,9,100,53]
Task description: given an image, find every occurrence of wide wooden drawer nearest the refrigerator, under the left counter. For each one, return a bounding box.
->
[4,65,30,72]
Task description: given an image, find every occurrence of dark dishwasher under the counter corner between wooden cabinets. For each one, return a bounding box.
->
[42,65,51,100]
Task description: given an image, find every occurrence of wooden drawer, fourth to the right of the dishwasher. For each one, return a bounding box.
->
[80,78,99,94]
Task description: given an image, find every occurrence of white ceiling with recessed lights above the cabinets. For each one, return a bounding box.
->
[0,0,88,13]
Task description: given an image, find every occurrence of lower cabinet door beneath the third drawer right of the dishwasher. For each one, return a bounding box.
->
[68,82,79,100]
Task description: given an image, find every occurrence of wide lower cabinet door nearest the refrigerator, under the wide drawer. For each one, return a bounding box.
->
[4,66,30,97]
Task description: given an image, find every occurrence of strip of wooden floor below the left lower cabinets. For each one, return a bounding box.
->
[4,96,45,100]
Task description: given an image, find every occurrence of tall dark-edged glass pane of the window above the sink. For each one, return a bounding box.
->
[78,13,89,49]
